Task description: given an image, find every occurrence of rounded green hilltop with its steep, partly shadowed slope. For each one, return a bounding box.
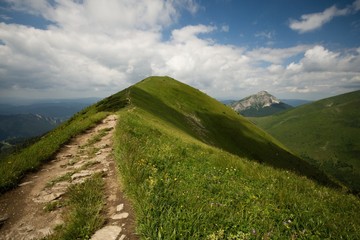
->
[129,77,330,186]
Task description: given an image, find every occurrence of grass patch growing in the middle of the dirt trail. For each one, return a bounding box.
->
[45,174,104,240]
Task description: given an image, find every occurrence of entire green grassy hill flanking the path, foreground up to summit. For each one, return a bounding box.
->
[0,77,360,239]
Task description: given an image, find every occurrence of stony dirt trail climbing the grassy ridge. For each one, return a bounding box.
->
[0,115,138,240]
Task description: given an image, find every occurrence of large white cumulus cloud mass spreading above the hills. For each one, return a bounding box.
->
[0,0,360,98]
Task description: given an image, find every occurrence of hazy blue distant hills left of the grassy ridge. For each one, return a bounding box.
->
[0,98,98,153]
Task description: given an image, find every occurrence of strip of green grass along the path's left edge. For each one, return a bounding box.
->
[0,89,128,194]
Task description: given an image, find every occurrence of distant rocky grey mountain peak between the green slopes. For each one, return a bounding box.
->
[230,91,292,117]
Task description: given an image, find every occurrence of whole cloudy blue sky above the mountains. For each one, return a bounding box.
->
[0,0,360,103]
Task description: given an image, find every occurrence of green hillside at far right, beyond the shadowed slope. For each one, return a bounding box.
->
[251,91,360,193]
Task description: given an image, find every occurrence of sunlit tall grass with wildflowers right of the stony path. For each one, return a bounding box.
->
[116,108,360,239]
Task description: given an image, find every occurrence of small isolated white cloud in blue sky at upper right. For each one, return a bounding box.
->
[289,6,351,33]
